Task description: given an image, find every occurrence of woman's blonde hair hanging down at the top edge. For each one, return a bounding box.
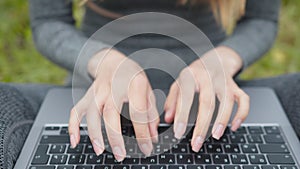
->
[80,0,246,33]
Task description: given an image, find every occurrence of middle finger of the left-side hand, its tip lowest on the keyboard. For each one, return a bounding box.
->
[103,95,126,161]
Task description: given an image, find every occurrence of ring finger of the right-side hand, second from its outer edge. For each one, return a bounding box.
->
[212,90,234,140]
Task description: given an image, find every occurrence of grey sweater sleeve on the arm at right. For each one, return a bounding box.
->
[220,0,280,69]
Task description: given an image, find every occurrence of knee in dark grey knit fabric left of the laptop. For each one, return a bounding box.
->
[0,83,57,168]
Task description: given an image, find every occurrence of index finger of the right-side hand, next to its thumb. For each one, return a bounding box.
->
[174,69,195,139]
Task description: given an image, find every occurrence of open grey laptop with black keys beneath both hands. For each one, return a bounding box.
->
[15,87,300,169]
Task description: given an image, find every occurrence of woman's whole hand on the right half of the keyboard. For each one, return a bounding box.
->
[165,46,250,152]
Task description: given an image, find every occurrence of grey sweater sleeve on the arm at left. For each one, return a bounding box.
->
[29,0,107,82]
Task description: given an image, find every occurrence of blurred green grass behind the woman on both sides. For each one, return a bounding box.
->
[0,0,300,84]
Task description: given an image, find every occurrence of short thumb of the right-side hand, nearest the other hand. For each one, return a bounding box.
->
[165,81,179,123]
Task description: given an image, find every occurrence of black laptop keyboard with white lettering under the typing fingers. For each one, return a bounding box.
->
[29,125,298,169]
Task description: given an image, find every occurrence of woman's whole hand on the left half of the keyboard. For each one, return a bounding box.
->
[69,49,159,161]
